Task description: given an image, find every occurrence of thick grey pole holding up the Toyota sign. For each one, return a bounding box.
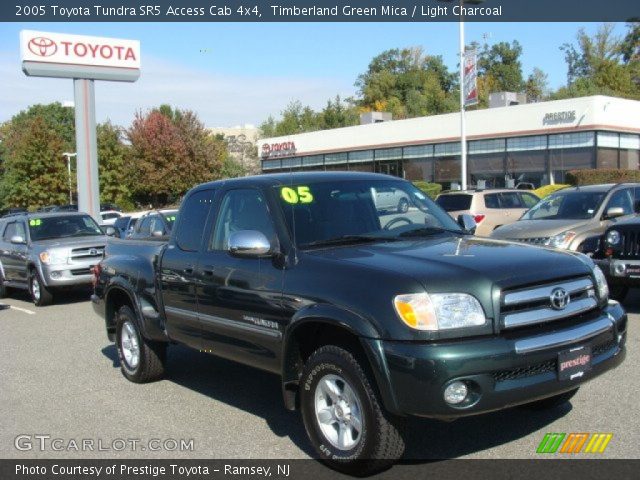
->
[73,78,100,222]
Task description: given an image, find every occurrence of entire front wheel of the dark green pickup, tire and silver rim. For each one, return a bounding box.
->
[300,345,404,475]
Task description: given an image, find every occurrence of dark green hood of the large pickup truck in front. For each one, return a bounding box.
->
[307,236,592,293]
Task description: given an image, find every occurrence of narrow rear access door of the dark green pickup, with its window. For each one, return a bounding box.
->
[160,189,214,348]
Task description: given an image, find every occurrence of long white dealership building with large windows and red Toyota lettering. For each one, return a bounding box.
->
[258,96,640,188]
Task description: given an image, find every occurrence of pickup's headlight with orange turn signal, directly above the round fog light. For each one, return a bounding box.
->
[393,292,487,331]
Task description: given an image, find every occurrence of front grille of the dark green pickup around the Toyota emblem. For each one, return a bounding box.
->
[500,277,598,329]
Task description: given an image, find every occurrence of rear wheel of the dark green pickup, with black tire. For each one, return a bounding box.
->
[116,306,167,383]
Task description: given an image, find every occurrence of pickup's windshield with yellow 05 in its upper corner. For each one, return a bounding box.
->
[275,180,464,248]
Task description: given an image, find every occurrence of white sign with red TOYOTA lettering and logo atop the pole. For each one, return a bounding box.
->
[20,30,140,81]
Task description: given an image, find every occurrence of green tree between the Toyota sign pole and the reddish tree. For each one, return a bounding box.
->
[97,122,134,210]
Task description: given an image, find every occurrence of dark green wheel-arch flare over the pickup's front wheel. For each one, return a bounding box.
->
[282,304,399,414]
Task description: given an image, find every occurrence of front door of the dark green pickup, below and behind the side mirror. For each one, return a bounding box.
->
[197,188,283,372]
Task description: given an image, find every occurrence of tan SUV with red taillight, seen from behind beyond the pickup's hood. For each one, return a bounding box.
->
[436,189,540,237]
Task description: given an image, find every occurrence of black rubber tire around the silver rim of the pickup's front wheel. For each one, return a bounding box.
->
[300,345,404,475]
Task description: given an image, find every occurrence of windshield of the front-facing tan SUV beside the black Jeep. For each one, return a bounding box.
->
[521,190,606,220]
